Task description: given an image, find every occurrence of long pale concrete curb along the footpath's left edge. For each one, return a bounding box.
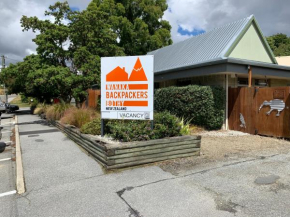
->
[15,116,25,194]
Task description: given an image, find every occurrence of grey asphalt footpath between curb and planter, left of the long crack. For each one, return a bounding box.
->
[17,115,172,217]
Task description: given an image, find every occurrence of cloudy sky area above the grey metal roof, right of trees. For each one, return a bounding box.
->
[163,0,290,42]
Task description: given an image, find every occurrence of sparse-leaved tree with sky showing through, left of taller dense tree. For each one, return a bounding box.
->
[20,2,74,67]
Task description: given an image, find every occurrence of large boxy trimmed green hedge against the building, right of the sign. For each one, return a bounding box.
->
[154,85,225,130]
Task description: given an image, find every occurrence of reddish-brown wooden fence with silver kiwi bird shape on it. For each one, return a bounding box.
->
[228,87,290,138]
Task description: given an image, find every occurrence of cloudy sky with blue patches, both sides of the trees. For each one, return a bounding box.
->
[0,0,290,64]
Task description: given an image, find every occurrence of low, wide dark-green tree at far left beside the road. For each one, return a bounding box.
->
[1,55,77,102]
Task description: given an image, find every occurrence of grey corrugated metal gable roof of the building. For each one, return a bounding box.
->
[148,15,277,73]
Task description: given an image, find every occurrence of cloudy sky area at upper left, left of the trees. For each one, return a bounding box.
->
[0,0,90,65]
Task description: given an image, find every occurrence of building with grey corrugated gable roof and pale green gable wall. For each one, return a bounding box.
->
[148,15,290,131]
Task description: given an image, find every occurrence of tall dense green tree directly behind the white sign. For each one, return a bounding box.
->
[69,2,124,96]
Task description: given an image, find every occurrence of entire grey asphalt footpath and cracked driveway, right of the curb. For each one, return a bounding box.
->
[0,114,290,217]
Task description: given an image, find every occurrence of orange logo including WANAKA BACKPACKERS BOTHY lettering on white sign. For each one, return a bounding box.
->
[106,58,148,107]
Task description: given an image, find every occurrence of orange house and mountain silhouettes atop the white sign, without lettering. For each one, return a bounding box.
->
[106,58,148,82]
